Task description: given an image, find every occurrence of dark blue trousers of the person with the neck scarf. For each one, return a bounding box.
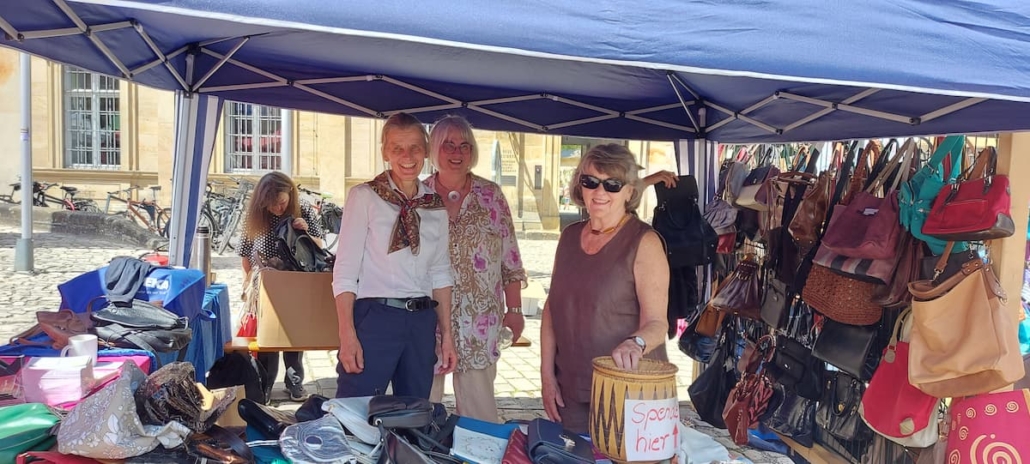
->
[336,299,437,399]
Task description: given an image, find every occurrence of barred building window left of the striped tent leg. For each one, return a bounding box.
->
[64,66,122,169]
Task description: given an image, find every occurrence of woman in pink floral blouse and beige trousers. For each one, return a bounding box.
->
[424,115,526,422]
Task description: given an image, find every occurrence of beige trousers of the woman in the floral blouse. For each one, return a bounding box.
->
[430,364,501,423]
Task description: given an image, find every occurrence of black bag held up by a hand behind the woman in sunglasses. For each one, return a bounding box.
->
[652,175,719,269]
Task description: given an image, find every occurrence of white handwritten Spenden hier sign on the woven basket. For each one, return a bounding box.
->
[622,397,680,462]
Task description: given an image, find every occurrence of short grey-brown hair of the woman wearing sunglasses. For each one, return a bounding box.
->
[570,143,644,212]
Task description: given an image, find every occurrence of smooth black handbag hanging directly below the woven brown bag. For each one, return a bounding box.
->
[812,318,877,380]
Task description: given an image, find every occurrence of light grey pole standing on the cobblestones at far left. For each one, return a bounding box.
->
[14,53,35,272]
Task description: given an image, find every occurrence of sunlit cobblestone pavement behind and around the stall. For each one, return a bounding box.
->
[0,225,791,463]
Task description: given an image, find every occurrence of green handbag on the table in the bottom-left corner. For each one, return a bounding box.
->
[0,403,60,462]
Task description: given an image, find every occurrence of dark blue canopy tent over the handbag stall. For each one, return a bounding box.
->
[0,0,1030,263]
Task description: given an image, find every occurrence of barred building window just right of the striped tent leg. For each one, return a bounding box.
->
[226,101,282,172]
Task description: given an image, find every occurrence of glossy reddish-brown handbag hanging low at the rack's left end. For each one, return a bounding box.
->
[722,335,775,445]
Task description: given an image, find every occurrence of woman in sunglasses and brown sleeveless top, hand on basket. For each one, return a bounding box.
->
[540,143,668,433]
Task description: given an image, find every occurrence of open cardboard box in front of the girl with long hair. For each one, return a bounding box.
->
[258,269,340,350]
